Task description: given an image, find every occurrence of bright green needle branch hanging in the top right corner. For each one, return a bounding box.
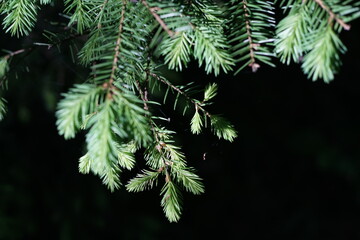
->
[275,0,360,82]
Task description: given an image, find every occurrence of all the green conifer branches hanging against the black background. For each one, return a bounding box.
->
[0,0,360,222]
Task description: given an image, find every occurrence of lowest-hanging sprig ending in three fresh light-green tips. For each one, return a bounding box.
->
[126,126,204,222]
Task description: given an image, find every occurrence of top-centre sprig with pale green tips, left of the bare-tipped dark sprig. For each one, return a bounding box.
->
[153,0,234,75]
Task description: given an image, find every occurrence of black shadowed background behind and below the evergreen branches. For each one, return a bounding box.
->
[0,4,360,240]
